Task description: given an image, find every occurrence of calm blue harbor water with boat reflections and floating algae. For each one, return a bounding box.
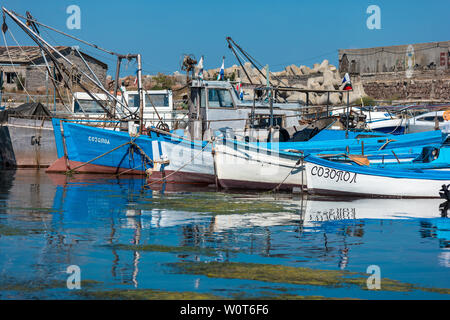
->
[0,169,450,299]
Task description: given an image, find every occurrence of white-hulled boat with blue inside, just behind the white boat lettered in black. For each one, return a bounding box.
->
[214,132,442,191]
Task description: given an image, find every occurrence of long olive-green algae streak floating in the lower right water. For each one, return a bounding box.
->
[168,262,450,294]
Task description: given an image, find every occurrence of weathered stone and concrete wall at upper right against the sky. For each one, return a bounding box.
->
[339,41,450,103]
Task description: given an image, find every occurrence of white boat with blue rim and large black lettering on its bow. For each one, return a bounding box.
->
[304,155,450,198]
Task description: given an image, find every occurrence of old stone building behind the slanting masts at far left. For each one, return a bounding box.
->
[0,46,108,92]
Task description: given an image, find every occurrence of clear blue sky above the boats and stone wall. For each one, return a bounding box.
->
[1,0,450,74]
